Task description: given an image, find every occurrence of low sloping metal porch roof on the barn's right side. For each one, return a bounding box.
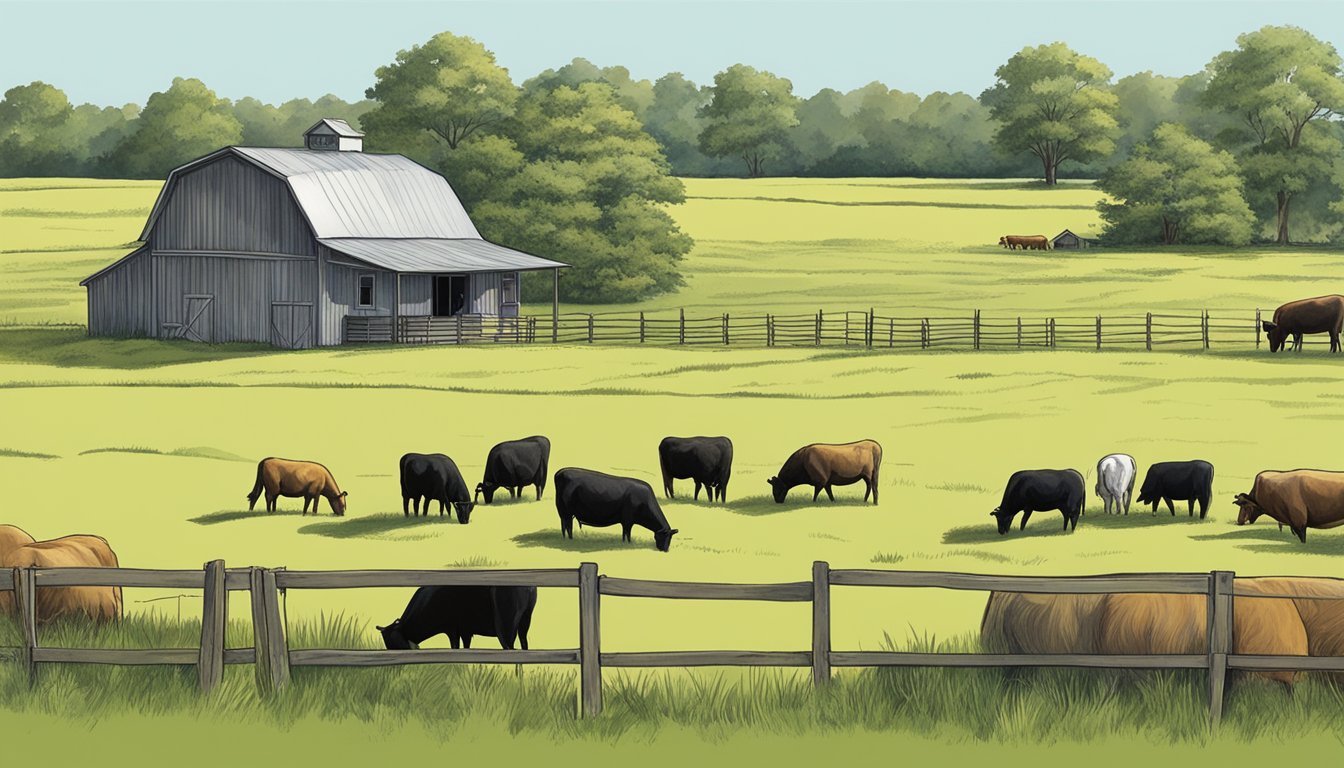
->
[317,237,569,273]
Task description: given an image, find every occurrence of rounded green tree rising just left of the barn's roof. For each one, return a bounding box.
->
[108,78,243,179]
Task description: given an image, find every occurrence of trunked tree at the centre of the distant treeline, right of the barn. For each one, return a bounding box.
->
[699,65,798,178]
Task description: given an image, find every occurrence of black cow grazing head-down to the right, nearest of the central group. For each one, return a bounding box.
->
[555,467,677,551]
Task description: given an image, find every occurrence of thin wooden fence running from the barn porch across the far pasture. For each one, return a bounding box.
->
[345,309,1290,350]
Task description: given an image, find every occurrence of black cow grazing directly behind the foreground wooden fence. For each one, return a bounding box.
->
[378,586,536,651]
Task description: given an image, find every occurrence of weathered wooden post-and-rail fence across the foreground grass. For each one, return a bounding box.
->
[0,560,1344,726]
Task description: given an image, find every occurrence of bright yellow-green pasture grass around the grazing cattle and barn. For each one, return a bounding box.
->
[0,179,1344,760]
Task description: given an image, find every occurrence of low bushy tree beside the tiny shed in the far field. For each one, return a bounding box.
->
[1097,122,1255,245]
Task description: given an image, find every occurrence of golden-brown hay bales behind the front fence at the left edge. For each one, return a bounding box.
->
[0,526,121,624]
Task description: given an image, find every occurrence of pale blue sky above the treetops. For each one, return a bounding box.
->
[0,0,1344,105]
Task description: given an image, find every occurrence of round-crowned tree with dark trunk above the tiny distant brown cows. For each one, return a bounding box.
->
[980,43,1118,184]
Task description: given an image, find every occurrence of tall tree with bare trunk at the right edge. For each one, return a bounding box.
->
[1204,27,1344,245]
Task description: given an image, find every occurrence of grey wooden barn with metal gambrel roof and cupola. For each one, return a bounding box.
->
[81,118,566,348]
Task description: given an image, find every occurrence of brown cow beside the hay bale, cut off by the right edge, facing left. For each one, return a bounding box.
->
[1234,469,1344,543]
